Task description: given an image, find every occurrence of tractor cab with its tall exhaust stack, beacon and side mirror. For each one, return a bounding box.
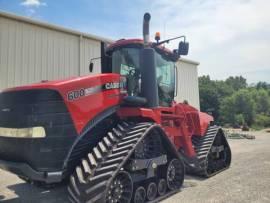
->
[101,13,189,108]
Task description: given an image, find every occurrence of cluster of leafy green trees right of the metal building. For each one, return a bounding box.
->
[199,75,270,127]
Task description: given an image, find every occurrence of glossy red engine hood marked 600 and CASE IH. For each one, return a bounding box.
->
[2,73,123,134]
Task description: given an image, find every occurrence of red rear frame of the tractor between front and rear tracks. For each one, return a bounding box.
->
[117,103,213,157]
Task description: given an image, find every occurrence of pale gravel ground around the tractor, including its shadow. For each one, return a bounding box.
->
[0,131,270,203]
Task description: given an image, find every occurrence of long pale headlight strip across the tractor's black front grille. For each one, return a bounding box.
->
[0,127,46,138]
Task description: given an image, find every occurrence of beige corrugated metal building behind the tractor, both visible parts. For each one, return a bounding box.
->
[0,12,199,108]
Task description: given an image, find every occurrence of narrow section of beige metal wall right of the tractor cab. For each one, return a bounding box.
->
[175,60,200,109]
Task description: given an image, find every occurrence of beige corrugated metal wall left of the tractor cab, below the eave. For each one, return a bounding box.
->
[0,15,101,89]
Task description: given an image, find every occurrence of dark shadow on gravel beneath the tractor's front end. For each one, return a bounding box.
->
[0,183,69,203]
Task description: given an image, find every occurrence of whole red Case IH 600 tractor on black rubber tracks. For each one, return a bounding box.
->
[0,13,231,203]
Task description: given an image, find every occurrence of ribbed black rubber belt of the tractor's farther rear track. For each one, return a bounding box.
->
[192,125,230,177]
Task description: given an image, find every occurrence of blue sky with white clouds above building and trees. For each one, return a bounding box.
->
[0,0,270,83]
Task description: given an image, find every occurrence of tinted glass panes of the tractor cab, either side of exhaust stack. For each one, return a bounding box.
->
[112,48,175,106]
